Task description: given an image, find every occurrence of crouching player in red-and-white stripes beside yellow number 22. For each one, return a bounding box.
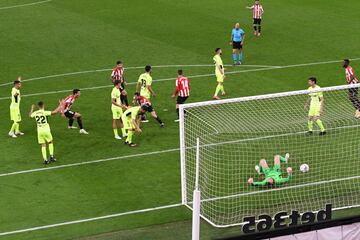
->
[62,89,89,134]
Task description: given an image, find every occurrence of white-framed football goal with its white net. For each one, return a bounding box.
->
[180,85,360,227]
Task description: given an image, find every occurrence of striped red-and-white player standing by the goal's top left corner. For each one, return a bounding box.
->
[172,69,190,122]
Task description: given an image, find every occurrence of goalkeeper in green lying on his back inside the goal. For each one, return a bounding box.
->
[248,153,292,186]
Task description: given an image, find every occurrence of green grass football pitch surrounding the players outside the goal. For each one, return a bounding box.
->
[0,0,360,240]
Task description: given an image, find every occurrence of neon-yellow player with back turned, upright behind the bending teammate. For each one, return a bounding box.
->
[135,65,155,122]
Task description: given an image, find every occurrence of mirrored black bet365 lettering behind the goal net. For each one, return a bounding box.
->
[243,204,331,233]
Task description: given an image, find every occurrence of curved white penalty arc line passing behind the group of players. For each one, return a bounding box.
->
[0,64,278,87]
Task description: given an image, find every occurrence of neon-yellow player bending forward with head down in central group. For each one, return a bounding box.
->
[121,106,146,147]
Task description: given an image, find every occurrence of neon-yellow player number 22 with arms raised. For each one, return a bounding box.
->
[29,102,62,165]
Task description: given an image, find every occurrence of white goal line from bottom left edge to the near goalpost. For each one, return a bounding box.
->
[0,203,182,236]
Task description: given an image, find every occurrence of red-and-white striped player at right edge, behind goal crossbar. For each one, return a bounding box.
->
[343,59,360,118]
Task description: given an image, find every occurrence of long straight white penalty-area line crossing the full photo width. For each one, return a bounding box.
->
[0,58,360,100]
